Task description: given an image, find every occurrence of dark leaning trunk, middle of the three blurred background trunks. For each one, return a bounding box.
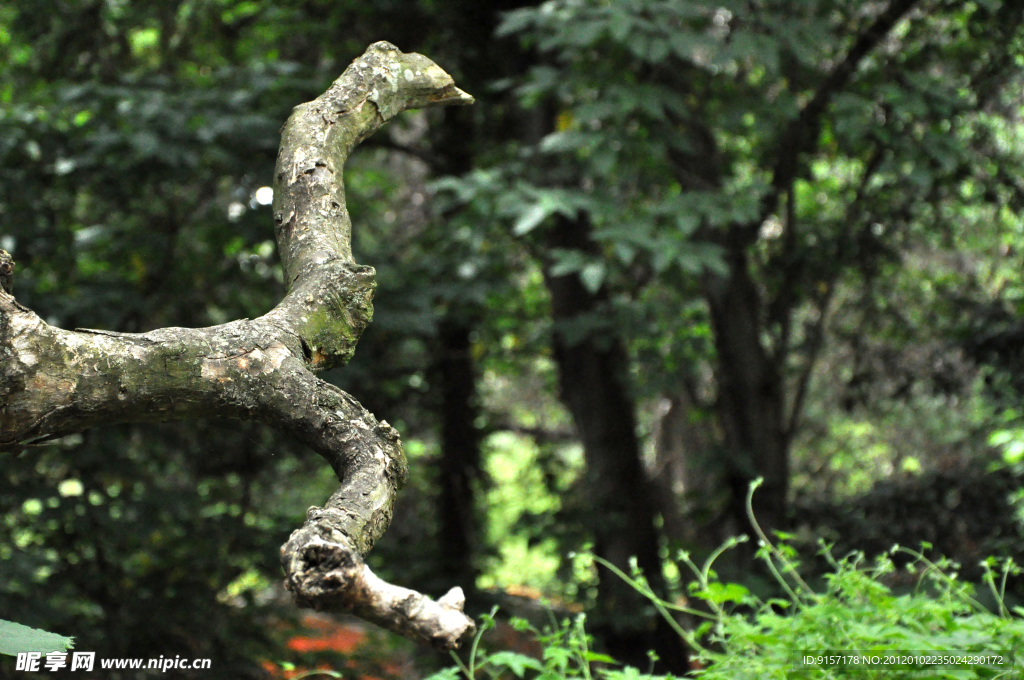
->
[545,216,688,673]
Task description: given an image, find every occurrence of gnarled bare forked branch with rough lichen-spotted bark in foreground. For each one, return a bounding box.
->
[0,42,473,649]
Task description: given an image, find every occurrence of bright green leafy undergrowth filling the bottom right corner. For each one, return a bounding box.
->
[622,483,1024,679]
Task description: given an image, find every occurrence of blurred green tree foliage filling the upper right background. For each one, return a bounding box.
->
[481,0,1024,522]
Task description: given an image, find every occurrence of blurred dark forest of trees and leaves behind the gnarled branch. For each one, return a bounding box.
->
[0,0,1024,677]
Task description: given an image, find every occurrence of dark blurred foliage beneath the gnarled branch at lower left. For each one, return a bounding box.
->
[0,423,319,673]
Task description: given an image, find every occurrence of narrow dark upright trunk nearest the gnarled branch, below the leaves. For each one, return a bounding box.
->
[436,314,480,586]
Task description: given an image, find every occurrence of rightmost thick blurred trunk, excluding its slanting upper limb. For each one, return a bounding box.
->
[670,98,792,544]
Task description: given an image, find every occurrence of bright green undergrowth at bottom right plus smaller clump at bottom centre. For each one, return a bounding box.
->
[428,480,1024,680]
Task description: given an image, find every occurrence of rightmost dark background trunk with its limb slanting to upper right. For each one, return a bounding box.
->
[682,0,929,544]
